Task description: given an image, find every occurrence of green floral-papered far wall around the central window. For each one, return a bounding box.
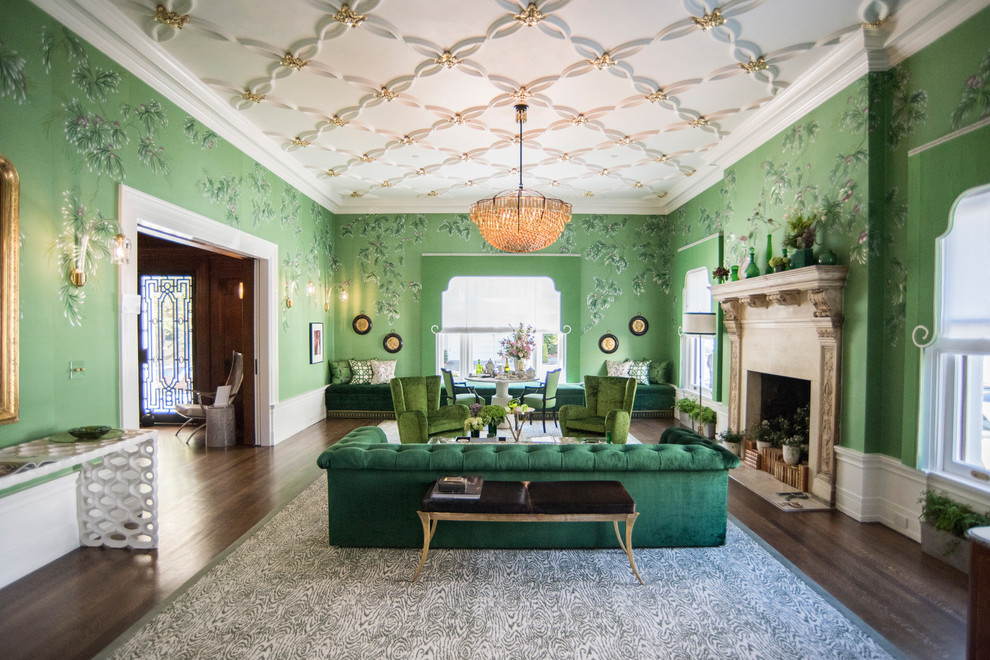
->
[332,214,673,382]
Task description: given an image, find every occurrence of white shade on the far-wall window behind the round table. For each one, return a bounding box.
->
[442,277,560,333]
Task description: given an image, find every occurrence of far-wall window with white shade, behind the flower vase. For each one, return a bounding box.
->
[437,277,566,380]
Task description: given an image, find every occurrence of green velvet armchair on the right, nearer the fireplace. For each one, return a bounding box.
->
[560,376,636,445]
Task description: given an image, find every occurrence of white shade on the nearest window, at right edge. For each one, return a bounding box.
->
[938,189,990,339]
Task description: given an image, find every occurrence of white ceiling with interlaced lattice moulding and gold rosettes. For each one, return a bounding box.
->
[36,0,944,212]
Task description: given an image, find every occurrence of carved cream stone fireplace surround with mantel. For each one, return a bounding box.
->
[711,266,848,504]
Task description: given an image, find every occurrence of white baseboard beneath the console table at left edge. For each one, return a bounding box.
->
[0,473,79,587]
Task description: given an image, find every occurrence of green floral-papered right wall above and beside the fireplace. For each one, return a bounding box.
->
[670,5,990,466]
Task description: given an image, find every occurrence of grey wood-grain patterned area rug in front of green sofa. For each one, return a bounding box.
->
[99,477,901,660]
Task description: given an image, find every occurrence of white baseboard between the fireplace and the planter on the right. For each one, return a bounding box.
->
[835,447,928,541]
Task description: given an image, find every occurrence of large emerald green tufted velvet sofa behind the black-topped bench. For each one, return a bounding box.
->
[317,426,739,548]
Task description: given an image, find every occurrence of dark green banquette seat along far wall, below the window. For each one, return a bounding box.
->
[323,382,676,419]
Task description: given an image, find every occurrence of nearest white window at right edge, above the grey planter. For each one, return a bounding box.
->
[918,186,990,490]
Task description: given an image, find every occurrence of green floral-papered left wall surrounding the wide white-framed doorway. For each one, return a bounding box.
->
[0,0,333,446]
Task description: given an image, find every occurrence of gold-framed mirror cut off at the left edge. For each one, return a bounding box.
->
[0,156,21,424]
